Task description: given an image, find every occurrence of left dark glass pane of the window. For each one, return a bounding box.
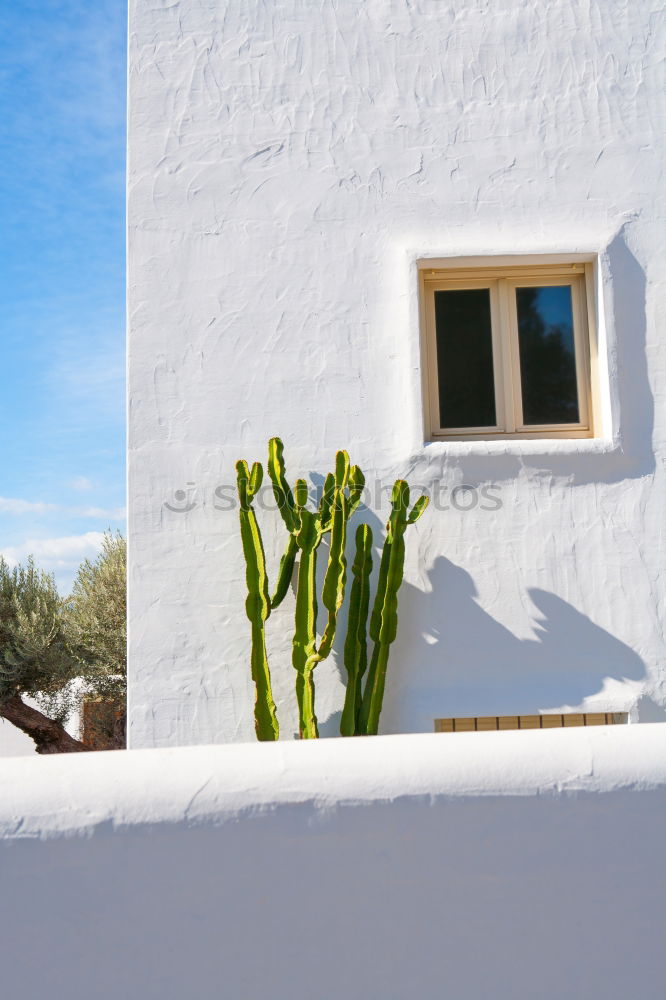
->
[435,288,497,427]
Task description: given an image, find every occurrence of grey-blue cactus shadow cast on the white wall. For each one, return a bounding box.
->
[381,556,645,732]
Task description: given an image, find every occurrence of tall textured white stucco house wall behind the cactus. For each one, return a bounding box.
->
[128,0,666,747]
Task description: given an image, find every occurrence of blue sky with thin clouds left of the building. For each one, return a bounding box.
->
[0,0,126,590]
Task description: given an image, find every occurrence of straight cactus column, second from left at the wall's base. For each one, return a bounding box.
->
[292,508,321,739]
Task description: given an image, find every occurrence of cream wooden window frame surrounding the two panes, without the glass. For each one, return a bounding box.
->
[419,261,598,441]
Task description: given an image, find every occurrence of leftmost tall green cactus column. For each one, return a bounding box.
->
[236,461,280,740]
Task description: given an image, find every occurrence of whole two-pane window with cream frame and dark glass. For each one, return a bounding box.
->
[420,261,593,439]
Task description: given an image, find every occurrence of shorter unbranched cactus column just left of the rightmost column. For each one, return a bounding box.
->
[340,524,372,736]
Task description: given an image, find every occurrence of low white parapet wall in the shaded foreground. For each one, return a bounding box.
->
[0,724,666,1000]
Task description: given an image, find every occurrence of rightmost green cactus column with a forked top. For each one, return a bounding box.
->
[359,479,428,736]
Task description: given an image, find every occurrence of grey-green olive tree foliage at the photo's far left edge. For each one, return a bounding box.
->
[0,557,79,722]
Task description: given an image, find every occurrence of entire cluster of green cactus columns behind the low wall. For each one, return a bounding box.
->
[236,438,428,740]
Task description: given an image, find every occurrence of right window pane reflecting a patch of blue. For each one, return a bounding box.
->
[516,285,580,424]
